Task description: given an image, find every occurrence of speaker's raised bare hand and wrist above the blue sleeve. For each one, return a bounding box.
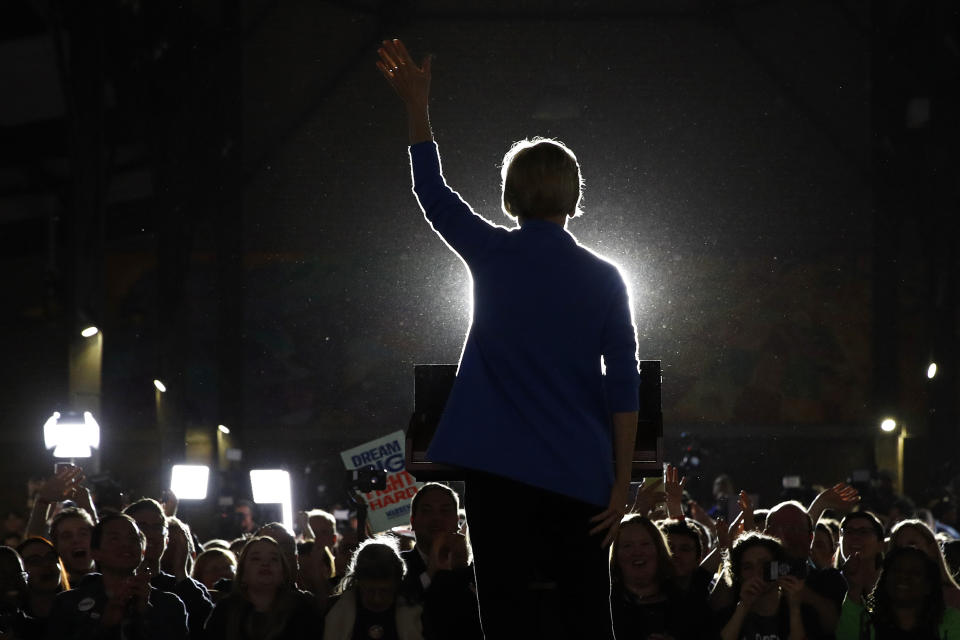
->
[377,38,433,144]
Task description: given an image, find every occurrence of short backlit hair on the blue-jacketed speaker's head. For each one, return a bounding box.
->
[500,137,583,218]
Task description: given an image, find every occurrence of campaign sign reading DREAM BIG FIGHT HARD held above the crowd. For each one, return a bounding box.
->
[340,431,419,533]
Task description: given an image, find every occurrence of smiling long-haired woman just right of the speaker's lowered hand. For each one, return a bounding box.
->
[610,514,715,640]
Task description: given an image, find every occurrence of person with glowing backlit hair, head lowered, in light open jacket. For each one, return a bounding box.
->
[323,536,423,640]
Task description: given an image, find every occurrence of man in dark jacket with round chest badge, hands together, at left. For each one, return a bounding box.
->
[47,514,188,640]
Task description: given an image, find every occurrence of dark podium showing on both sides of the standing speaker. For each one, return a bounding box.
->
[404,360,663,482]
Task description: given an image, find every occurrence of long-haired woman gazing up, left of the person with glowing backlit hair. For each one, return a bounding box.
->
[204,536,322,640]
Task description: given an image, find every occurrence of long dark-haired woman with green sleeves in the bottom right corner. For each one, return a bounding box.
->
[836,546,960,640]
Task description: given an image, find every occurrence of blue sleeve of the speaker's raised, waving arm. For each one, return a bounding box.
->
[410,142,507,265]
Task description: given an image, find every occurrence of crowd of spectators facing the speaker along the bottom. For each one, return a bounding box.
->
[0,467,960,640]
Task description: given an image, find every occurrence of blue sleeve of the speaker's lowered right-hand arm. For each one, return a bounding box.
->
[602,273,640,413]
